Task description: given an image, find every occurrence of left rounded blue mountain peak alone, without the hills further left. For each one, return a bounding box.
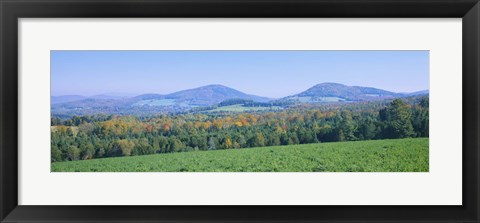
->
[165,84,270,106]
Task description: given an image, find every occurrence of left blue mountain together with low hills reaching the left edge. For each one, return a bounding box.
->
[51,85,270,115]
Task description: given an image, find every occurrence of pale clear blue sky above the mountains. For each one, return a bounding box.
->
[51,51,429,98]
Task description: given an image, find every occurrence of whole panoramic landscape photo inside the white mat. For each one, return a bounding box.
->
[50,50,429,172]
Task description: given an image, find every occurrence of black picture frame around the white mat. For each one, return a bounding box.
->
[0,0,480,222]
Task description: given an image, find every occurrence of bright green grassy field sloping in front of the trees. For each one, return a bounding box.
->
[51,138,429,172]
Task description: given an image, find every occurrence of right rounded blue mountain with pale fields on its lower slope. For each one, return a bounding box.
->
[281,83,405,102]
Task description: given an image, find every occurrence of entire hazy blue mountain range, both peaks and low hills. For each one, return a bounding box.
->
[51,83,429,115]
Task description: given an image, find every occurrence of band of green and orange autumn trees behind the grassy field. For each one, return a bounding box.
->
[51,97,429,162]
